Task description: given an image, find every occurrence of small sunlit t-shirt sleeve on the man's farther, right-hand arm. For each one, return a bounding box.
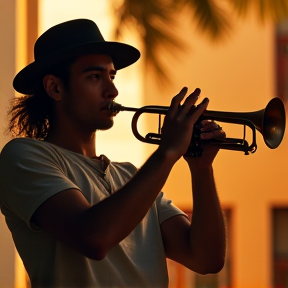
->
[156,192,188,224]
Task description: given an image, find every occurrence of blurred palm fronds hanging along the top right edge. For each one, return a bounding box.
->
[111,0,288,83]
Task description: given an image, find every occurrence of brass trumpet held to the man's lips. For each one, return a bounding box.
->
[109,97,286,156]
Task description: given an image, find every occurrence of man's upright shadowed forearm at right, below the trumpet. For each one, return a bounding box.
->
[190,166,226,270]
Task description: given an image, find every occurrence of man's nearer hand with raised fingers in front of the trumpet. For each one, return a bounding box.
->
[158,87,209,161]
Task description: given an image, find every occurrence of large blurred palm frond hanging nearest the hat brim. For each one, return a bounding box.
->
[115,0,185,82]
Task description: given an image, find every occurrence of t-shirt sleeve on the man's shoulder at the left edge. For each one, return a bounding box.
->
[0,139,80,228]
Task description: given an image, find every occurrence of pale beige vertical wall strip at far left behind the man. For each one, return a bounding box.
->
[0,0,16,288]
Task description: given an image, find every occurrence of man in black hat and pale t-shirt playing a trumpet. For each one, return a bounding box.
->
[0,19,225,288]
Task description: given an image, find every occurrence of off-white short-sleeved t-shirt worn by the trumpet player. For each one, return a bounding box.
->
[0,138,184,288]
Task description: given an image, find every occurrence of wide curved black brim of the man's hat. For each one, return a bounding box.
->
[13,41,140,95]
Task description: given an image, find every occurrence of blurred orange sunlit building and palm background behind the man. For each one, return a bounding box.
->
[0,0,288,288]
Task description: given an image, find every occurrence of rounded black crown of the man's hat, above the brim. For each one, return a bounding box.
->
[34,19,105,60]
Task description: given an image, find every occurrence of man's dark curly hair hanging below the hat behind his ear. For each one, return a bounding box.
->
[8,58,77,140]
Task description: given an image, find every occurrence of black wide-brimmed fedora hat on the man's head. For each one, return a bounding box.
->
[13,19,140,94]
